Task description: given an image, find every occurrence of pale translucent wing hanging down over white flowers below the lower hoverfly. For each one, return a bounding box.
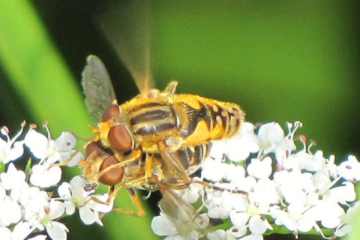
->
[159,189,201,236]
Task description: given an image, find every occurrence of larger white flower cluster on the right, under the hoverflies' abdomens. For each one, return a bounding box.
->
[152,122,360,240]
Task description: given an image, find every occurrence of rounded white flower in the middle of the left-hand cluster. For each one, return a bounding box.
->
[30,164,61,188]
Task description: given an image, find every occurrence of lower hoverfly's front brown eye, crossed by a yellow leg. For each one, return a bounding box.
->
[99,156,124,186]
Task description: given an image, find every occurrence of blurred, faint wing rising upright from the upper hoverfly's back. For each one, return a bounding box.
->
[100,0,154,93]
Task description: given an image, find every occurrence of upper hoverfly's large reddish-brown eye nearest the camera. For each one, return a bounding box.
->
[108,125,134,152]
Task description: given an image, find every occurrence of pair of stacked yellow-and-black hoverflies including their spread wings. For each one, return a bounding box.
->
[81,1,244,235]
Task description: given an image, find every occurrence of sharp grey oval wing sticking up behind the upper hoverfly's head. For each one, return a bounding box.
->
[81,55,116,122]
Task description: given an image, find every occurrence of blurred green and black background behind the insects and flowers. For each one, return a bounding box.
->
[0,0,360,239]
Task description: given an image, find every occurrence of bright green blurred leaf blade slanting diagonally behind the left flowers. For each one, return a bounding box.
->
[0,0,158,239]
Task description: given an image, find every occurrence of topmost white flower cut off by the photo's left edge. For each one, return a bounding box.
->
[0,124,24,164]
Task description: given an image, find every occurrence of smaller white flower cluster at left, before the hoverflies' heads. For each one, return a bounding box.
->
[0,124,112,240]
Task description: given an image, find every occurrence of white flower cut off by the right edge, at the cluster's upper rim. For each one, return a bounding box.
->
[338,155,360,181]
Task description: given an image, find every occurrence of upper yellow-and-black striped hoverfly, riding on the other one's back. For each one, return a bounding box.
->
[83,56,244,191]
